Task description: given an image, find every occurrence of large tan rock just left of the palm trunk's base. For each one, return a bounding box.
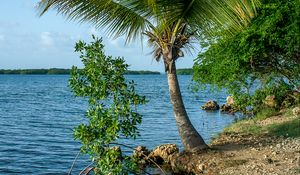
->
[148,144,179,164]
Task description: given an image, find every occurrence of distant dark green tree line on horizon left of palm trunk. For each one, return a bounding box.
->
[0,68,160,75]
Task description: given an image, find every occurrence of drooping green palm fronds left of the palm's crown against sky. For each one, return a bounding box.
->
[37,0,153,42]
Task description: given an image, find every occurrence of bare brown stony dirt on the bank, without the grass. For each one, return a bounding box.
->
[171,113,300,175]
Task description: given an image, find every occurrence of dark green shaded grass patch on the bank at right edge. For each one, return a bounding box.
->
[268,117,300,137]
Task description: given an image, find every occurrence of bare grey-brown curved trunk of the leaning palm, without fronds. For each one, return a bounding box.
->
[168,62,208,151]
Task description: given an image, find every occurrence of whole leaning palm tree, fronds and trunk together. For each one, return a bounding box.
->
[38,0,257,151]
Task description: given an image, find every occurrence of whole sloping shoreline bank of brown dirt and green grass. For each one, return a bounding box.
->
[142,106,300,175]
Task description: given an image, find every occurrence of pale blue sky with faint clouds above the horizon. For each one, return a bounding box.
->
[0,0,197,72]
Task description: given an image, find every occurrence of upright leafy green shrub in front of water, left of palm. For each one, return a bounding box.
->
[69,37,146,174]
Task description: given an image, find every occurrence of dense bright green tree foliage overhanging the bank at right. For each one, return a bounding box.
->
[194,0,300,112]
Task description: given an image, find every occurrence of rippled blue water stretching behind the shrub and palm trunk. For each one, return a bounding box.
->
[0,75,239,175]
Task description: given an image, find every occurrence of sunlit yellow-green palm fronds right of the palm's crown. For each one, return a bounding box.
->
[166,0,260,37]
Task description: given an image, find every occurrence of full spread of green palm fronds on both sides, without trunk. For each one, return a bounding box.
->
[38,0,259,42]
